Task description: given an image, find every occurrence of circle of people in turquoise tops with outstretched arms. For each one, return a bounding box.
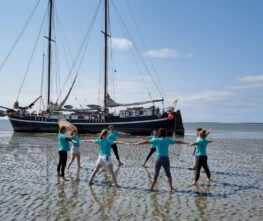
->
[57,125,212,191]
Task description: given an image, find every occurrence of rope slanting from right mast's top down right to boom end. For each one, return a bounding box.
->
[111,1,164,102]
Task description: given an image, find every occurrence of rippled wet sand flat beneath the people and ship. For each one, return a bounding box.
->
[0,133,263,221]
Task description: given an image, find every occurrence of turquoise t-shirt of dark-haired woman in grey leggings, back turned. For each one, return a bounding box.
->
[151,138,175,157]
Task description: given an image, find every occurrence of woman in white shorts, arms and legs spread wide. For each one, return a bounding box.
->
[83,129,126,187]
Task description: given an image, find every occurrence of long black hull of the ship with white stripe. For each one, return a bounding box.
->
[8,111,184,135]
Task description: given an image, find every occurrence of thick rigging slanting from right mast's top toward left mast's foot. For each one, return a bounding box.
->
[56,0,102,102]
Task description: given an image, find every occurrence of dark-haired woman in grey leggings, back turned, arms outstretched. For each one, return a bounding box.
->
[135,128,187,191]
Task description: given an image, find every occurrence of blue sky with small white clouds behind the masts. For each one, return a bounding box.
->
[0,0,263,122]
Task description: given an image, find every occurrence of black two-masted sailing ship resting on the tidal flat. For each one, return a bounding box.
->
[1,0,184,135]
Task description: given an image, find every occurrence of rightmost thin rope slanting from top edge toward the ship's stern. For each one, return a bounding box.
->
[126,0,170,103]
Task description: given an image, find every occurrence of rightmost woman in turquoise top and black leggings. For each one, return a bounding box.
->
[189,130,212,185]
